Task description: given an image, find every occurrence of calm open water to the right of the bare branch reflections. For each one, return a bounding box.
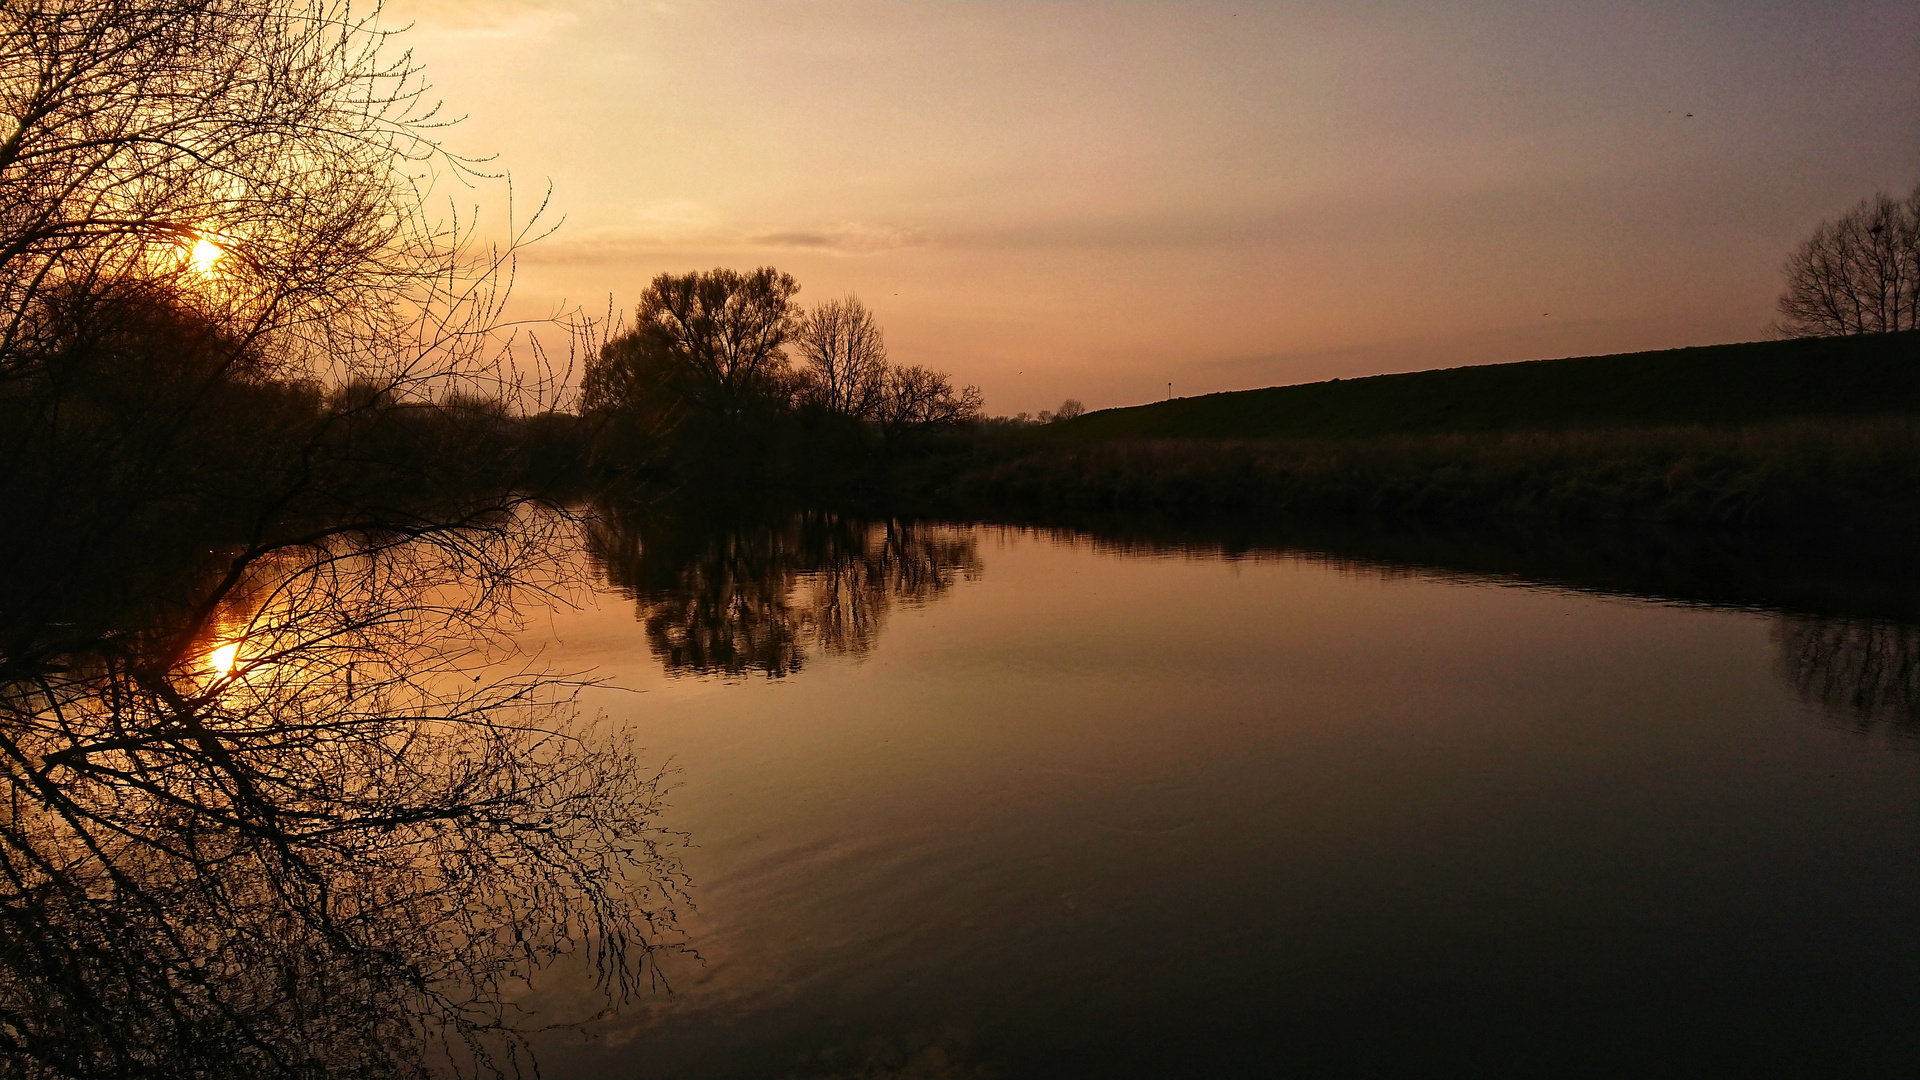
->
[528,527,1920,1078]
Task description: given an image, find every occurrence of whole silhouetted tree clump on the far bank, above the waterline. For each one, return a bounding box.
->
[580,267,981,500]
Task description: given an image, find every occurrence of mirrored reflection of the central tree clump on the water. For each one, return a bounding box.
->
[588,513,979,678]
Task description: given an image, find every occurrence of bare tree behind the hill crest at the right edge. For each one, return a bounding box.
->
[1774,184,1920,338]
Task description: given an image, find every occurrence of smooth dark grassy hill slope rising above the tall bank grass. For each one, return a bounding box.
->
[1046,331,1920,442]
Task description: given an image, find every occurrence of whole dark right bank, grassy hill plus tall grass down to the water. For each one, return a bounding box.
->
[948,332,1920,527]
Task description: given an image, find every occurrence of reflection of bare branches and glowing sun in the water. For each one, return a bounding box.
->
[0,511,678,1076]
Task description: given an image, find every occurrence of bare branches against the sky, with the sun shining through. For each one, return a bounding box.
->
[0,0,576,409]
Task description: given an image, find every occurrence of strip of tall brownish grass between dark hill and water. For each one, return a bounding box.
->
[950,417,1920,527]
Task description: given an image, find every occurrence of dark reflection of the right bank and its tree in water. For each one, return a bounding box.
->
[998,517,1920,738]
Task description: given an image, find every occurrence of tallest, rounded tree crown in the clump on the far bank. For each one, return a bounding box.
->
[582,267,801,419]
